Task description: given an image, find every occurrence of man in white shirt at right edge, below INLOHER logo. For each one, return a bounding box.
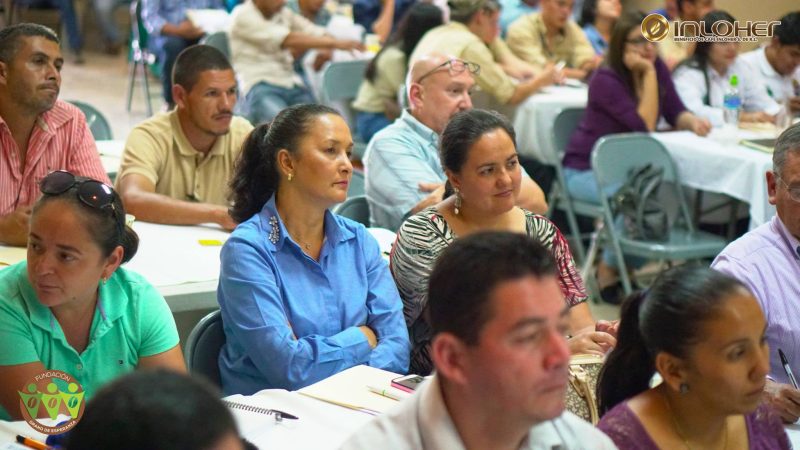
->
[741,11,800,114]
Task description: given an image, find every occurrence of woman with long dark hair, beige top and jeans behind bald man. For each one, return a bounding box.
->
[353,2,443,142]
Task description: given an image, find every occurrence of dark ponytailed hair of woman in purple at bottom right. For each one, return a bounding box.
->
[597,265,747,414]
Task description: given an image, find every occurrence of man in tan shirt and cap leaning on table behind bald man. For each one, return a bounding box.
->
[410,0,559,105]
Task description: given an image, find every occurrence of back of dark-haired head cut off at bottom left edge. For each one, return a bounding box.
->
[66,370,256,450]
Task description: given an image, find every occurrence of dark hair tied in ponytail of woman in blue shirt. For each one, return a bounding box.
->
[229,104,340,223]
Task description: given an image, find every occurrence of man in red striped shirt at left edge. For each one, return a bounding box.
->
[0,23,110,245]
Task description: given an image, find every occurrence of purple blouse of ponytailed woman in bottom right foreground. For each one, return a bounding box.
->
[597,402,792,450]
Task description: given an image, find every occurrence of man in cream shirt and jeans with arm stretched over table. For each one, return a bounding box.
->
[230,0,363,125]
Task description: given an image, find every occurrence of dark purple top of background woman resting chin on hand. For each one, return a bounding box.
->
[564,58,686,170]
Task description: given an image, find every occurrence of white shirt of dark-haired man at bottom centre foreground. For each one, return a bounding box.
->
[341,376,617,450]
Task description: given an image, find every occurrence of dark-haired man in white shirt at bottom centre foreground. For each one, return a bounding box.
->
[342,232,616,450]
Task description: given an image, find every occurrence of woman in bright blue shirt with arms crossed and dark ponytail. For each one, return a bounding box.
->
[217,105,409,394]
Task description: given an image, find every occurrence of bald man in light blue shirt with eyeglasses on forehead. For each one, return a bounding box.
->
[364,53,547,230]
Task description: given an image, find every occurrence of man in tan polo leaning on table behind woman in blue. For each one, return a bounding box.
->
[116,45,253,229]
